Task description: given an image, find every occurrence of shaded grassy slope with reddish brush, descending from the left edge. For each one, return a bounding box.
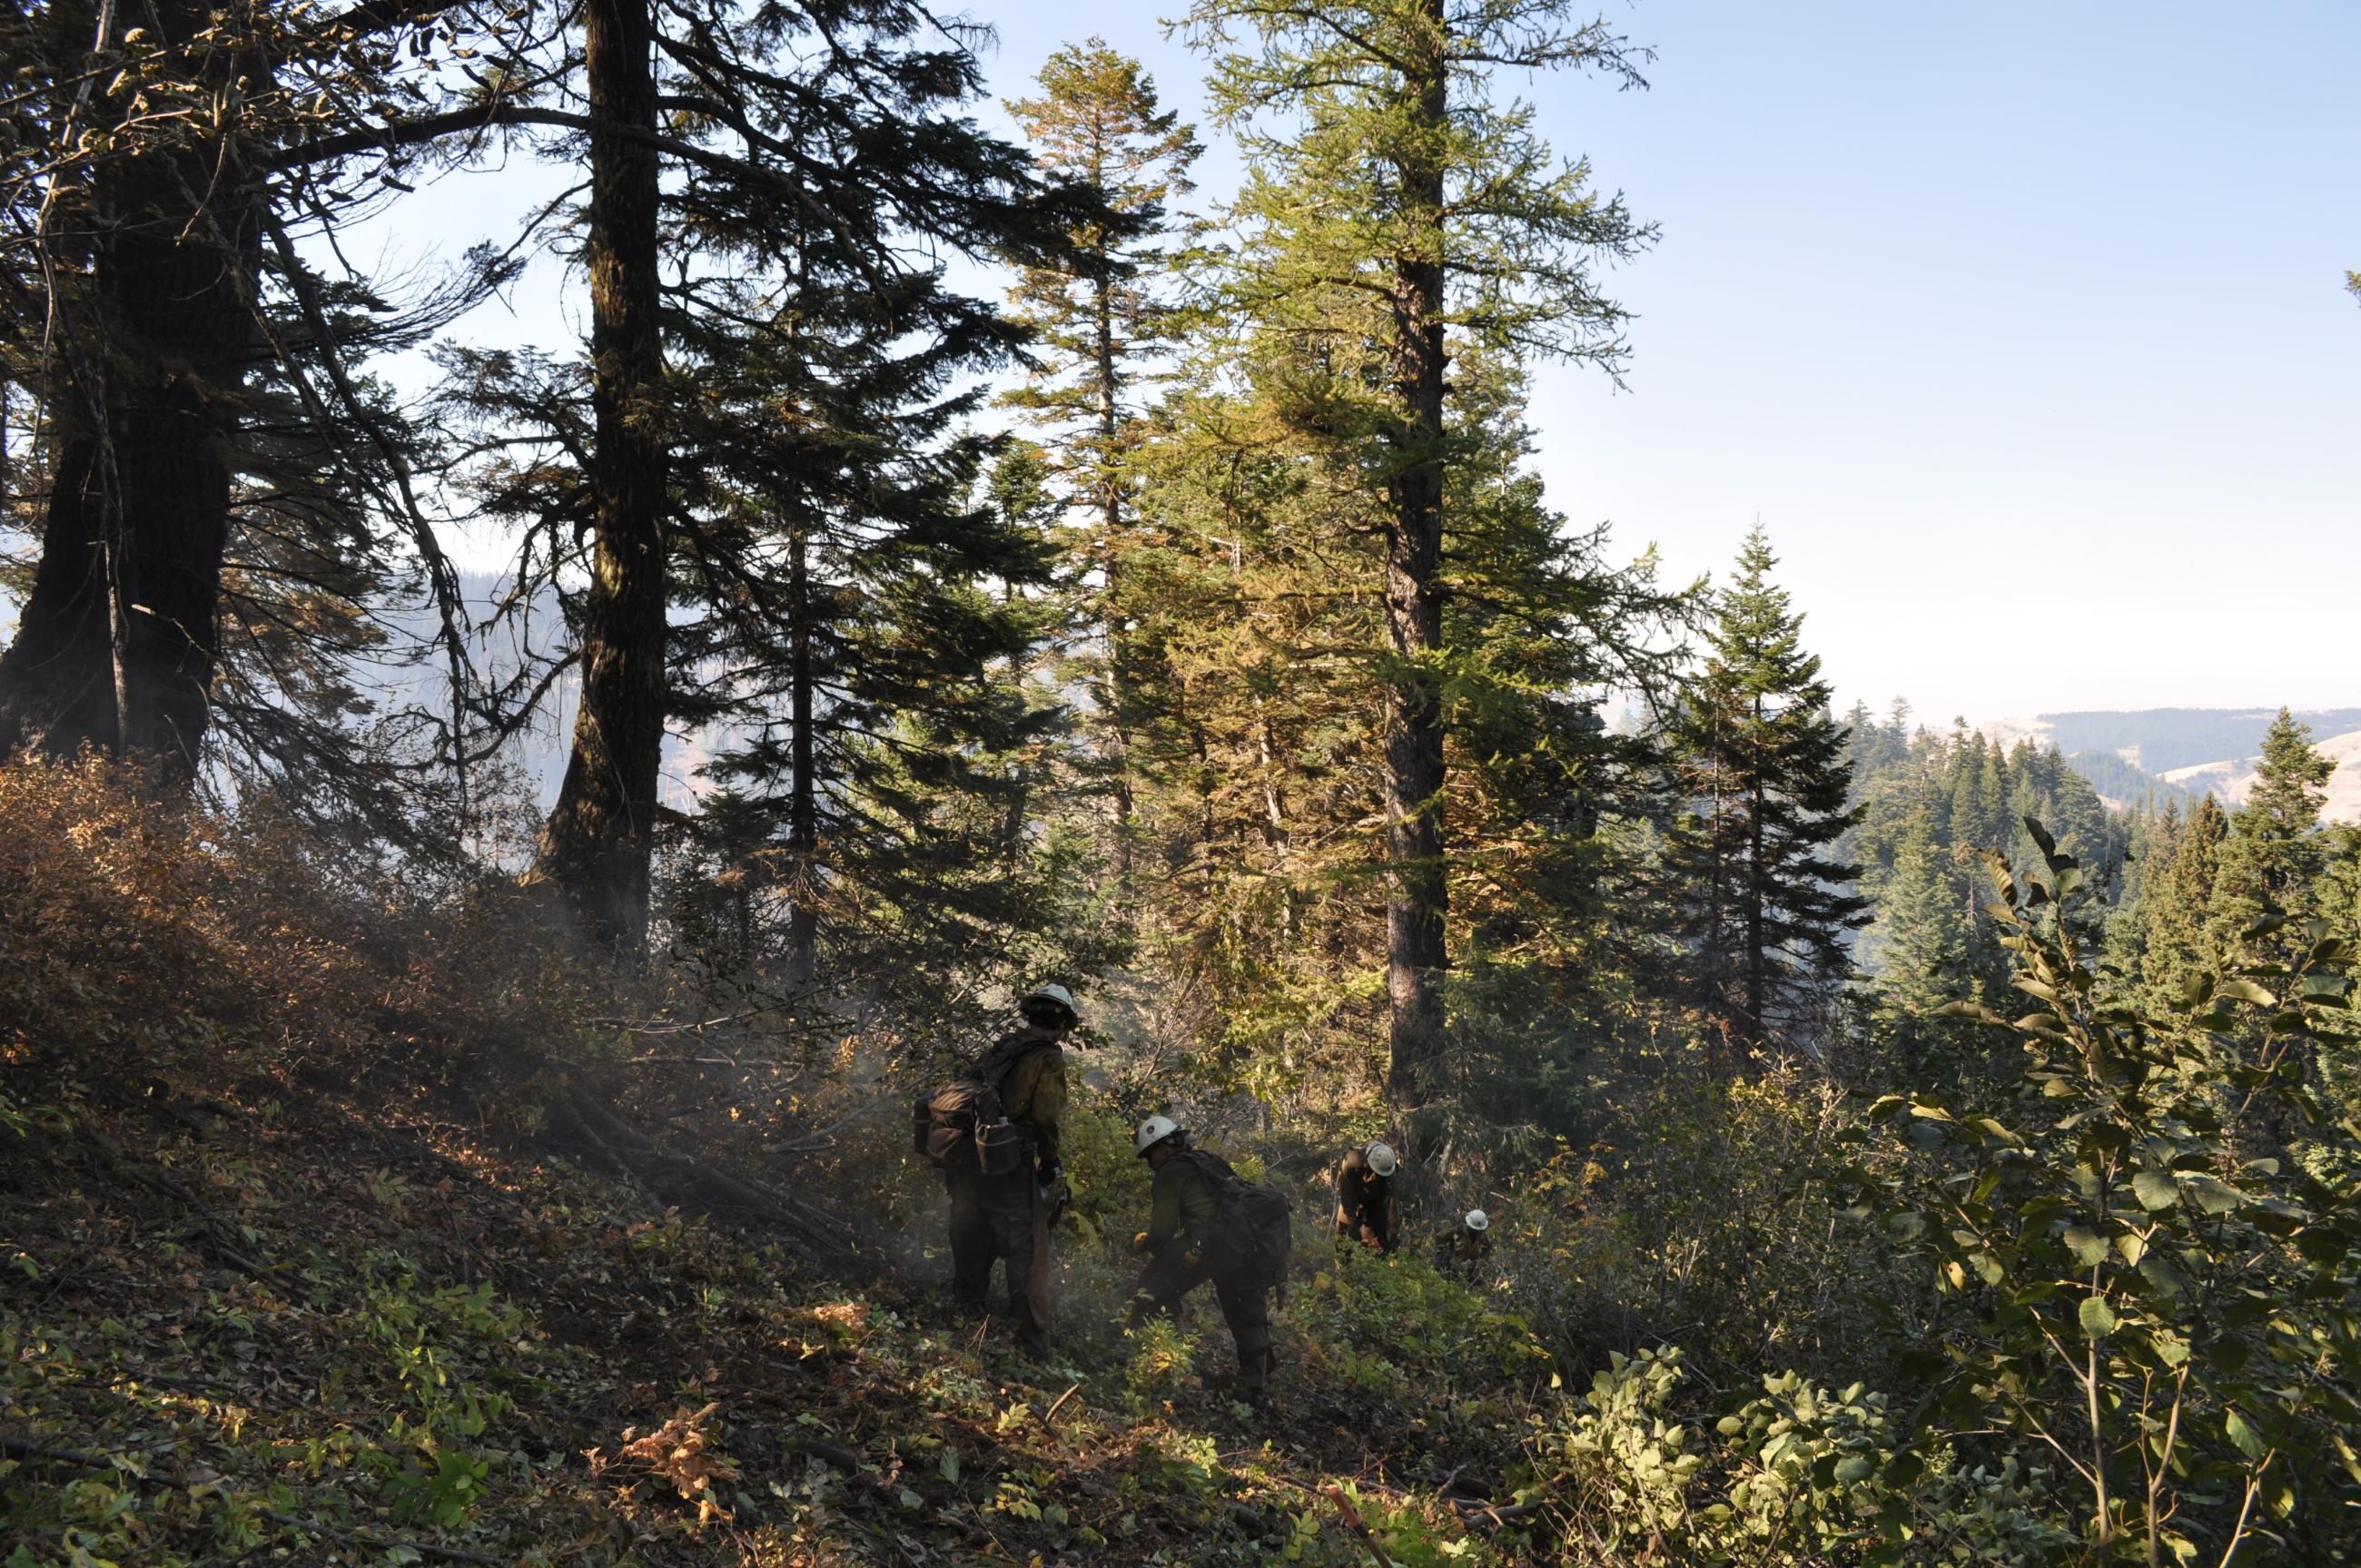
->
[0,755,1549,1568]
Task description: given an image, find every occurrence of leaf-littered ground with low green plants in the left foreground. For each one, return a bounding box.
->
[0,1039,1549,1568]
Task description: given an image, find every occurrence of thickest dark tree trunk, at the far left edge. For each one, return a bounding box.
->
[0,5,262,779]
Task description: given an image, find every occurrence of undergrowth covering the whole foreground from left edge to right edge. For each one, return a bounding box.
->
[0,765,2361,1568]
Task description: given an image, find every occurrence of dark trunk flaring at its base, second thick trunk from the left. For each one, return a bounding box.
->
[534,0,666,952]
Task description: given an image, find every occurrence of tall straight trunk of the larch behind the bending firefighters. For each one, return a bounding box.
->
[1384,0,1449,1157]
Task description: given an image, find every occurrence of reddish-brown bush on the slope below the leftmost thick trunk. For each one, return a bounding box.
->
[0,758,611,1091]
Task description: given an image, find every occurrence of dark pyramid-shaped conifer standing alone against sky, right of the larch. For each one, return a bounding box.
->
[1669,529,1868,1044]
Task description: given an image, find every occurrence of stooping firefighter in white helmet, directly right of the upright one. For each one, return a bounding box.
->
[1131,1117,1279,1400]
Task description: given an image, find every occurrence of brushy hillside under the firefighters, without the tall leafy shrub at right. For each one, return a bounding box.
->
[0,763,2219,1568]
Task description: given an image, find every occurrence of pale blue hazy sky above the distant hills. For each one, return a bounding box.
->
[359,0,2361,720]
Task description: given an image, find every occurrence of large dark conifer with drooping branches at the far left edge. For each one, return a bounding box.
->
[0,0,536,784]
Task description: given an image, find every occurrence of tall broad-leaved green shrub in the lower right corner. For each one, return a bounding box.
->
[1856,820,2361,1563]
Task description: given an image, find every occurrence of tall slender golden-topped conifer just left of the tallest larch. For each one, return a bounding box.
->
[1006,38,1201,883]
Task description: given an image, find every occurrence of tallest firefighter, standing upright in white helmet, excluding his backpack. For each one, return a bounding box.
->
[942,985,1077,1356]
